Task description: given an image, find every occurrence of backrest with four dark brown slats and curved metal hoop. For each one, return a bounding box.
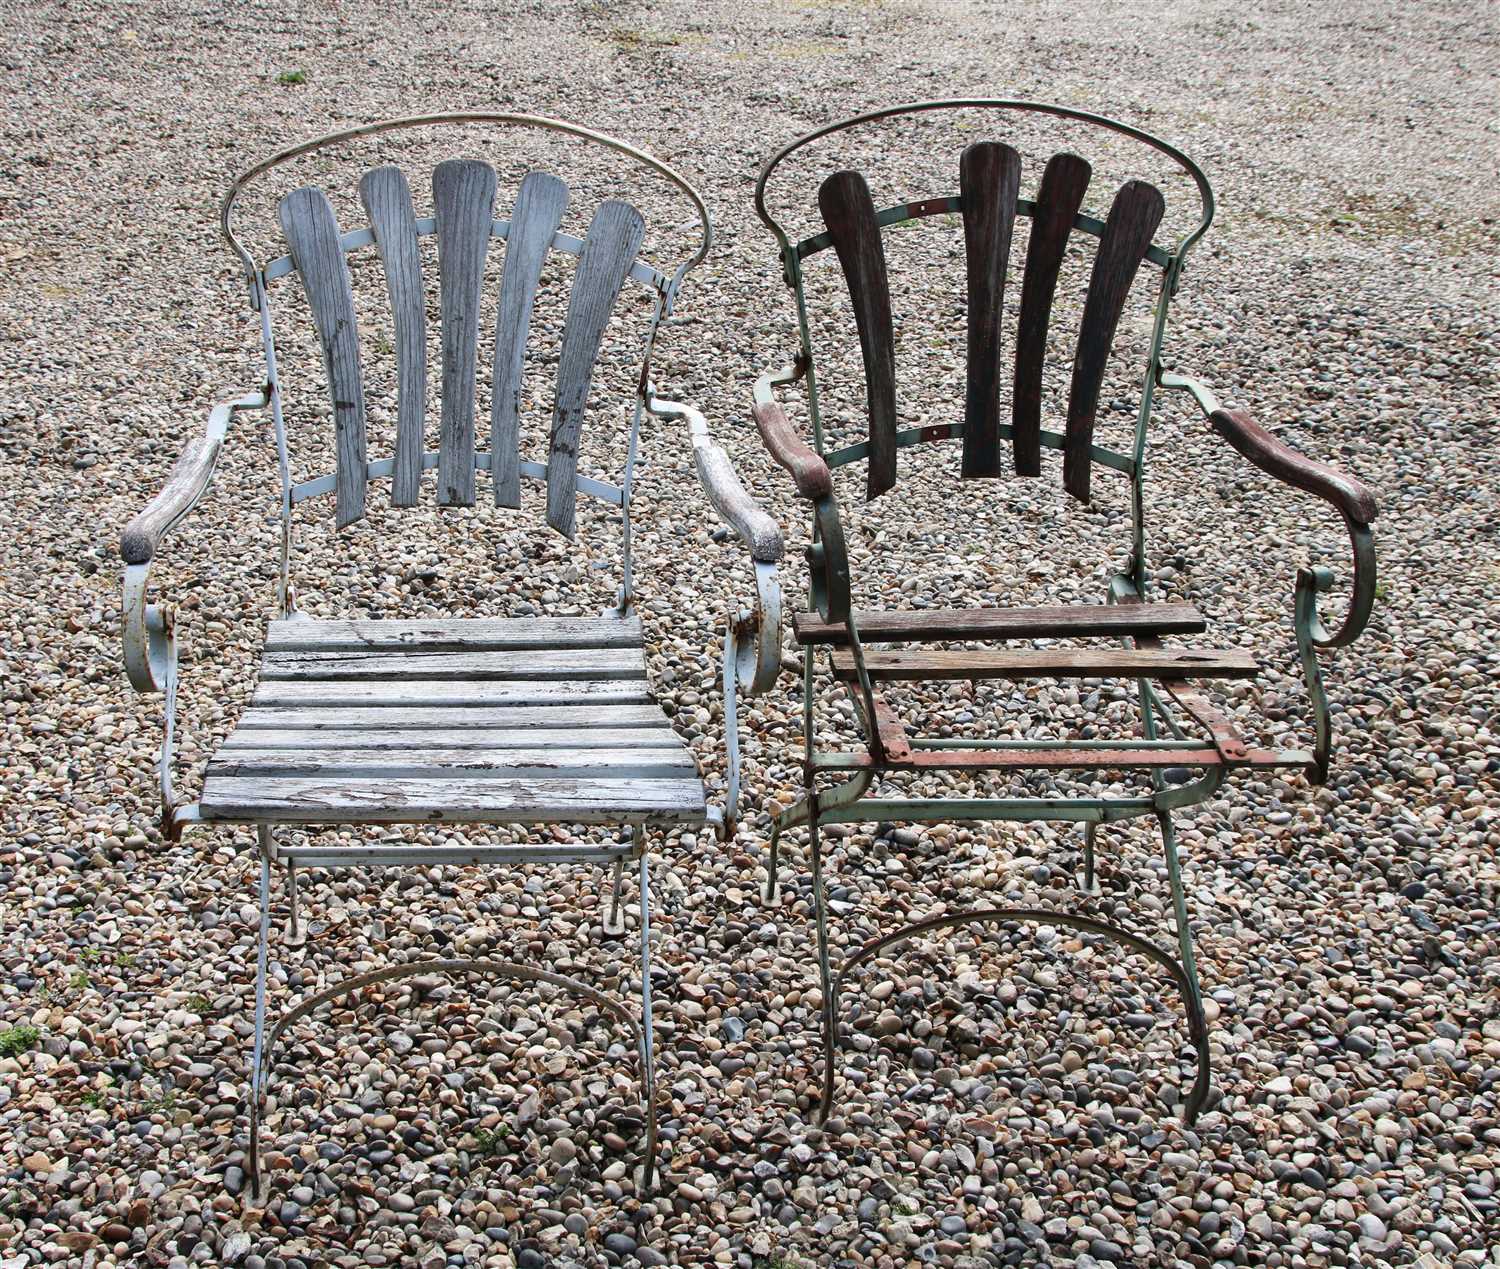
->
[756,101,1214,503]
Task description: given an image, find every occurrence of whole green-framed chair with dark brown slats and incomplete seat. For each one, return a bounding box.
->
[725,101,1376,1121]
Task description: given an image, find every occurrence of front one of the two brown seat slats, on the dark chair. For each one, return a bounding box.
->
[833,648,1260,681]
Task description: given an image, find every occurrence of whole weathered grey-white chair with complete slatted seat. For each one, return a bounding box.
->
[122,114,782,1199]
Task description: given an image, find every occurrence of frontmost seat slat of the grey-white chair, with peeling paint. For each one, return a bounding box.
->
[201,776,705,824]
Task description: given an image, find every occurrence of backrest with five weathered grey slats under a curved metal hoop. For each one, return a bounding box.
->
[221,114,711,555]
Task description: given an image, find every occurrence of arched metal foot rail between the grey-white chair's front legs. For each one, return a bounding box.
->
[248,959,657,1203]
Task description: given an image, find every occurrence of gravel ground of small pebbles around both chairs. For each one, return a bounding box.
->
[0,0,1500,1269]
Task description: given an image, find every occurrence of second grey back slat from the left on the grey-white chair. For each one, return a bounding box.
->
[360,167,428,507]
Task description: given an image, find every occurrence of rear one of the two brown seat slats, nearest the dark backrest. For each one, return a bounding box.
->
[792,603,1208,645]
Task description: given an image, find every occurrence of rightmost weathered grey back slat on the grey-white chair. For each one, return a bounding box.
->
[548,200,645,537]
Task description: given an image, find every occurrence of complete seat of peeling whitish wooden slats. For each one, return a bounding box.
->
[201,617,707,824]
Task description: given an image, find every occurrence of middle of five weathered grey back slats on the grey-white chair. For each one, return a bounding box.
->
[432,159,495,507]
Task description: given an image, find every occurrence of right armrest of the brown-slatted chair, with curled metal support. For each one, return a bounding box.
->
[1158,371,1379,648]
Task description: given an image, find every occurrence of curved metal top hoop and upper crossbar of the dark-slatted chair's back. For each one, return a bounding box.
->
[755,98,1214,269]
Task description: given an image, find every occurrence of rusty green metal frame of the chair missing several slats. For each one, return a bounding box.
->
[755,99,1374,1124]
